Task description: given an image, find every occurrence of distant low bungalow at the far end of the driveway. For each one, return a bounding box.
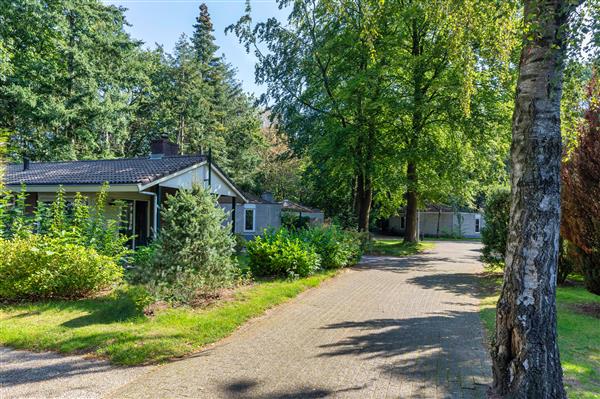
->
[382,205,485,238]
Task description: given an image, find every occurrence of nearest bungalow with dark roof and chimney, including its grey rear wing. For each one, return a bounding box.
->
[4,139,324,248]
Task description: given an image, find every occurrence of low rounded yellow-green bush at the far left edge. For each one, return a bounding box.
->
[0,234,123,300]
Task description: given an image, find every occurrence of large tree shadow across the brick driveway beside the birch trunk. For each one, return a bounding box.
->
[319,311,490,397]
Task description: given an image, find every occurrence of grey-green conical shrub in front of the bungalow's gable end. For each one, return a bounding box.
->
[135,186,237,302]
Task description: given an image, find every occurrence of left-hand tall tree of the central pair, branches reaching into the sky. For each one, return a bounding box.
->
[228,1,398,230]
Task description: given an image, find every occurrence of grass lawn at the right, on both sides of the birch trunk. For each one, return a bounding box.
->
[481,275,600,399]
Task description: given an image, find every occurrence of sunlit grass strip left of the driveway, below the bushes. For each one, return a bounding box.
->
[0,271,337,365]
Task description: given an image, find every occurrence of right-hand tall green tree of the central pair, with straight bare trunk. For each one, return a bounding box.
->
[390,0,517,242]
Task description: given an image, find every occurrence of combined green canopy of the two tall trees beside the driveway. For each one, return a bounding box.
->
[228,0,519,230]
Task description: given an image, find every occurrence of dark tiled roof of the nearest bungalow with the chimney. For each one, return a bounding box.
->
[4,155,206,185]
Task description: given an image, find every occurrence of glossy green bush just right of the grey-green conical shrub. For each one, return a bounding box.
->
[246,229,320,277]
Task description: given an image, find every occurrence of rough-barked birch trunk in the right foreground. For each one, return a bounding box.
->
[490,0,573,398]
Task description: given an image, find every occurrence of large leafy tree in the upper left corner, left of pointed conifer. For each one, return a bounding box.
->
[0,0,139,160]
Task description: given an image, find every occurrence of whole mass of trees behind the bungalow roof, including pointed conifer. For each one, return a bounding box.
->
[0,0,264,191]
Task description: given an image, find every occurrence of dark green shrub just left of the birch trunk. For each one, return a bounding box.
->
[481,189,510,262]
